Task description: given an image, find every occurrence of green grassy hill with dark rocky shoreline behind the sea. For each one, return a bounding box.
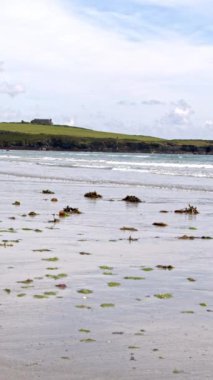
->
[0,123,213,154]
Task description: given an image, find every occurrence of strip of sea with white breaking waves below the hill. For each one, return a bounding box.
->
[0,150,213,192]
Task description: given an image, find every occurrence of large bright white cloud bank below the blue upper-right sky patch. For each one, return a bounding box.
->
[0,0,213,135]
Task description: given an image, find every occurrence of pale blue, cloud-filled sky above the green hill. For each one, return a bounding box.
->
[0,0,213,139]
